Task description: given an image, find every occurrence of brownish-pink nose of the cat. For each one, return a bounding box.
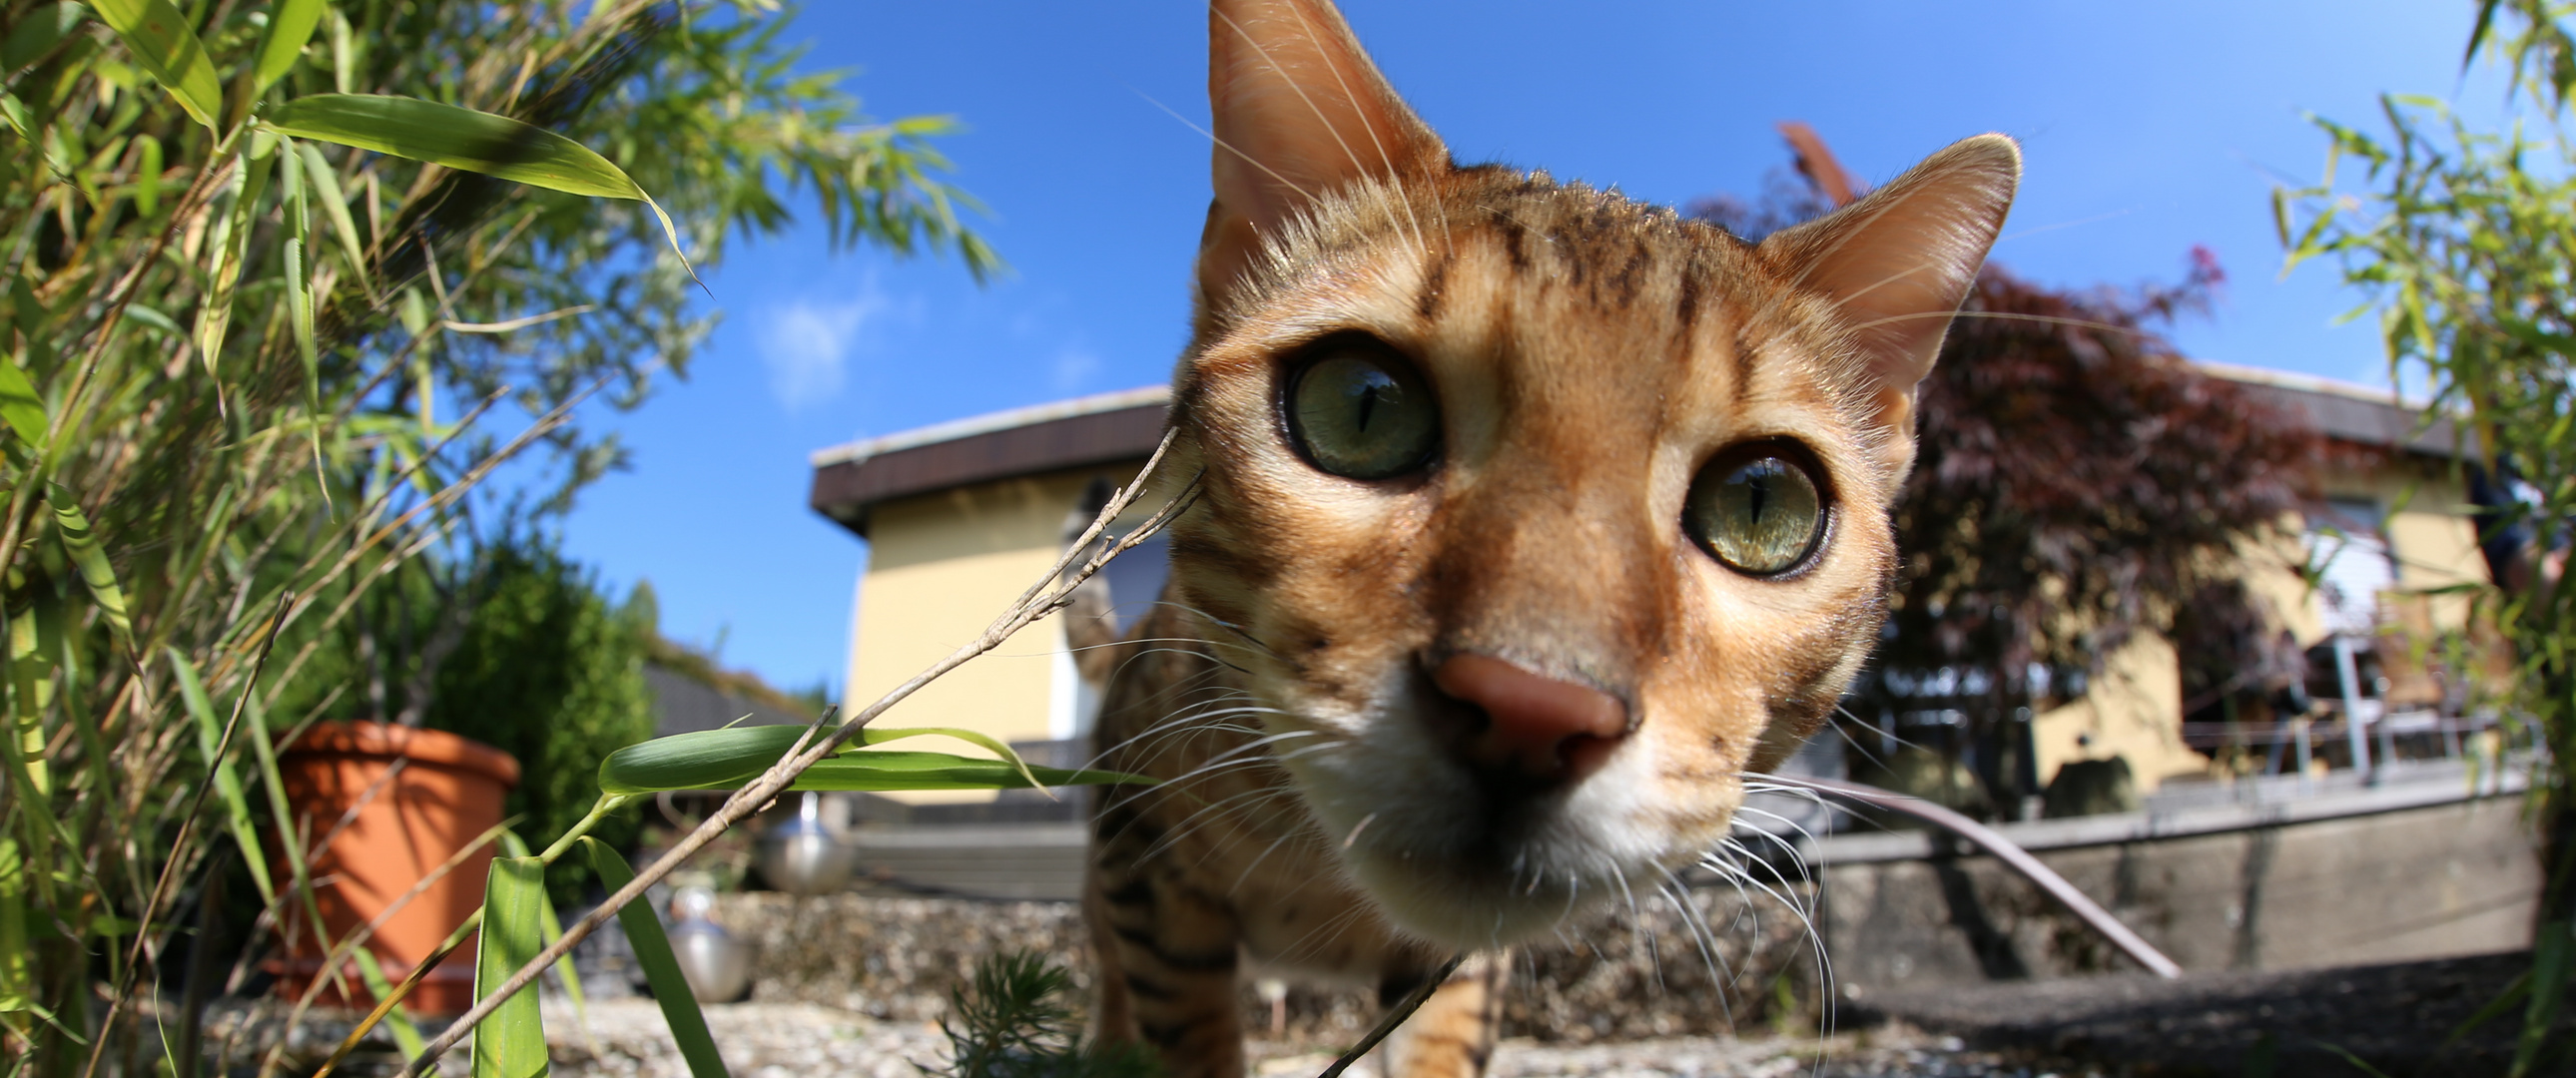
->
[1432,654,1628,785]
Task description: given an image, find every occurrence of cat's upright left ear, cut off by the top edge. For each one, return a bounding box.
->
[1198,0,1448,301]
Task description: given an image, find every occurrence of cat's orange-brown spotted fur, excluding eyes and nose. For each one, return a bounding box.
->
[1074,0,2020,1078]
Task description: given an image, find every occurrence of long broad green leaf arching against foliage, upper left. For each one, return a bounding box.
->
[263,93,696,275]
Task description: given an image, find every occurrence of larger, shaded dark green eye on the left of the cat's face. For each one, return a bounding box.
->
[1285,344,1440,478]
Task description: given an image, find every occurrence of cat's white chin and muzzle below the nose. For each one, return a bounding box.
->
[1291,744,1697,949]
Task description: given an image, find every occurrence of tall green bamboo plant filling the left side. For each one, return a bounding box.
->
[0,0,1076,1078]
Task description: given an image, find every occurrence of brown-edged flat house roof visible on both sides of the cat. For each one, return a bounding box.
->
[809,362,2475,538]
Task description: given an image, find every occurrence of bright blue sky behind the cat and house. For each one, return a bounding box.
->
[564,0,2496,687]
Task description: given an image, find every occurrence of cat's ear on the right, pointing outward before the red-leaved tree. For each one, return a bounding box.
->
[1762,134,2022,435]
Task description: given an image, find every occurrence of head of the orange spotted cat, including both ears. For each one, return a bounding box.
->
[1172,0,2020,947]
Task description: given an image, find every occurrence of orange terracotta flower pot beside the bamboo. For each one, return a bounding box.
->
[273,723,518,1014]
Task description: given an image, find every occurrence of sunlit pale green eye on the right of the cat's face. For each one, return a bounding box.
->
[1682,453,1824,576]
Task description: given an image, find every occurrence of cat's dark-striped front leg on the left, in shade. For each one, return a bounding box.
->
[1082,833,1244,1078]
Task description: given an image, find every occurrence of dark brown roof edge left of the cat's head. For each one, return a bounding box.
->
[807,393,1164,538]
